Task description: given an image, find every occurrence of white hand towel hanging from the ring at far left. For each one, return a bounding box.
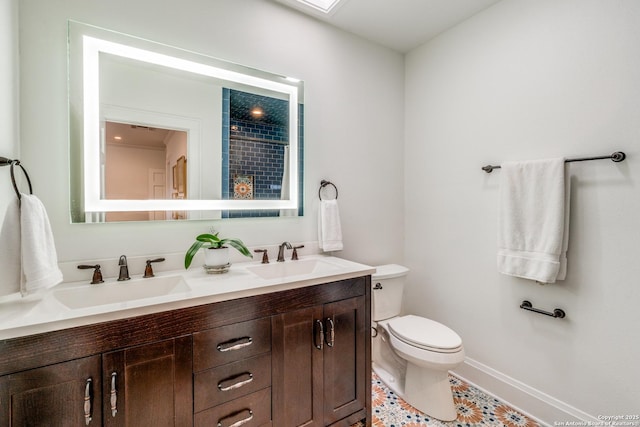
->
[20,194,62,296]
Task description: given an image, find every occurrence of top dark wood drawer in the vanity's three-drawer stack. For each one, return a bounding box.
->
[193,317,271,372]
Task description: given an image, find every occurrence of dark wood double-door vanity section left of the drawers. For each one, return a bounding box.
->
[0,337,192,427]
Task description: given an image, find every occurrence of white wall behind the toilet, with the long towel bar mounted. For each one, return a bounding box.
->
[405,0,640,422]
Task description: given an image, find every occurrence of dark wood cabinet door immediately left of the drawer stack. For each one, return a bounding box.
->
[102,336,193,427]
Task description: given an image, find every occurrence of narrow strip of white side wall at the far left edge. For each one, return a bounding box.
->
[0,0,19,224]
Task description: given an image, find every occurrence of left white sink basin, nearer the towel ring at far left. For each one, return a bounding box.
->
[53,276,191,309]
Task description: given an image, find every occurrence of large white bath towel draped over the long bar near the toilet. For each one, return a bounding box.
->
[498,158,569,283]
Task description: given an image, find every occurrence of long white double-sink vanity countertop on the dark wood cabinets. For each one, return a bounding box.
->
[0,255,374,339]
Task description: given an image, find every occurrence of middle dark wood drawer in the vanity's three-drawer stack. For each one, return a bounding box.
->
[193,353,271,412]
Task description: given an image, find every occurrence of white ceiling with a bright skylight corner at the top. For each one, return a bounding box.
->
[276,0,500,53]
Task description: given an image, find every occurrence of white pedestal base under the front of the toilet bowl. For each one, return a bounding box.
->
[404,363,457,421]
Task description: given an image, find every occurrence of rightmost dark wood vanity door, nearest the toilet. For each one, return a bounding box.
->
[324,297,368,425]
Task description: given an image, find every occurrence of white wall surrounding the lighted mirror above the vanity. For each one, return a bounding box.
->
[20,0,404,263]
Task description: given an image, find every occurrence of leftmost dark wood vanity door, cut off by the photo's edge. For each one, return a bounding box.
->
[0,356,102,427]
